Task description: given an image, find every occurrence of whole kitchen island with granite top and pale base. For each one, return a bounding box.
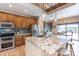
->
[25,36,68,56]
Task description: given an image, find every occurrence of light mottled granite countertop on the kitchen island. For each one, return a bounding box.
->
[25,36,68,54]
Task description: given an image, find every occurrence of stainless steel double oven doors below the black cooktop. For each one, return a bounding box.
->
[0,36,15,51]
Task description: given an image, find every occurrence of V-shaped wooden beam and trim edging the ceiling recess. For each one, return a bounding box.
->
[32,3,75,14]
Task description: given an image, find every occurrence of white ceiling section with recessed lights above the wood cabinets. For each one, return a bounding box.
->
[0,3,43,16]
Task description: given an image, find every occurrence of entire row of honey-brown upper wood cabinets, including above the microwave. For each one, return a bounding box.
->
[0,12,37,28]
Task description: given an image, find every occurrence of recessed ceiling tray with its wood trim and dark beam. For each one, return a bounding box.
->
[33,3,67,12]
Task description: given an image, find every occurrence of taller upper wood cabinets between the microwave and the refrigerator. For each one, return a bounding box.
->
[15,16,37,28]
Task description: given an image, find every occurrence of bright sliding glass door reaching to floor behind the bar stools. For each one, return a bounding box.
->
[58,23,79,56]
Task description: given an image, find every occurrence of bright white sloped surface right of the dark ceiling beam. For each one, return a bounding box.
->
[46,3,79,20]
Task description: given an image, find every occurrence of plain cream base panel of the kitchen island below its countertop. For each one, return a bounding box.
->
[26,41,42,56]
